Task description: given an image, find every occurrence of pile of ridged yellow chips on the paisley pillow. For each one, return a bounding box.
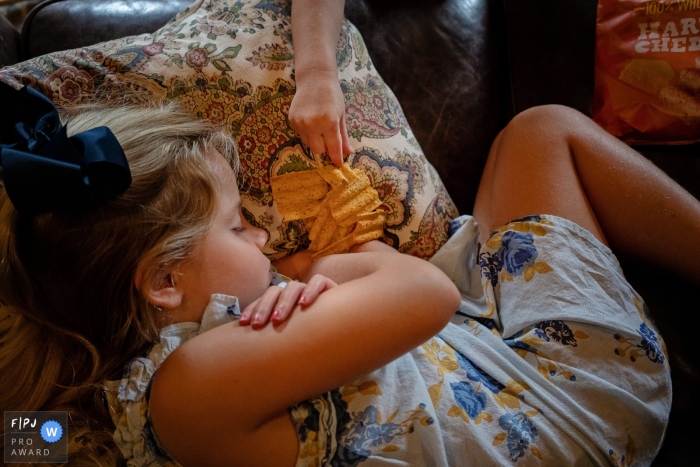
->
[270,163,386,261]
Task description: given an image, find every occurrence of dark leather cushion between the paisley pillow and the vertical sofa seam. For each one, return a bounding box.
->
[346,0,508,214]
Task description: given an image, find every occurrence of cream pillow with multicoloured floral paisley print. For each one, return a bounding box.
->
[0,0,457,259]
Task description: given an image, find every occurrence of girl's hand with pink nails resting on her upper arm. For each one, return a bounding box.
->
[238,274,338,329]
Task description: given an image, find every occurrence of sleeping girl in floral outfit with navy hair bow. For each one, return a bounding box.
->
[0,77,700,467]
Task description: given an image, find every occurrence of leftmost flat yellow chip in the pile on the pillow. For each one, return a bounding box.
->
[270,170,328,221]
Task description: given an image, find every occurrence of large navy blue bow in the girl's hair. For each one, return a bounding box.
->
[0,83,131,215]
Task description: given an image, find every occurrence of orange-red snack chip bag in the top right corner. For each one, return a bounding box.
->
[593,0,700,144]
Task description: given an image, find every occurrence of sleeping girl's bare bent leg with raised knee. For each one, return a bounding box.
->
[474,106,700,284]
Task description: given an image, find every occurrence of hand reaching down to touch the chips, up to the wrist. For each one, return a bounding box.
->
[289,71,352,167]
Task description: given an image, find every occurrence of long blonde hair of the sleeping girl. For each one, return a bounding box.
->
[0,103,238,465]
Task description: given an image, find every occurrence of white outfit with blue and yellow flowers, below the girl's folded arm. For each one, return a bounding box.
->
[291,216,671,467]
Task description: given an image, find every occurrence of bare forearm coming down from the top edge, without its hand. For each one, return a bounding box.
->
[292,0,345,82]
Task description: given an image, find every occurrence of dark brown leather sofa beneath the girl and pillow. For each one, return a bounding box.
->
[0,0,700,466]
